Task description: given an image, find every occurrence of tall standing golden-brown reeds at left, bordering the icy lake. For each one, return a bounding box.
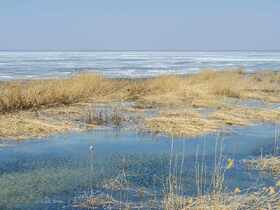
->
[0,74,120,113]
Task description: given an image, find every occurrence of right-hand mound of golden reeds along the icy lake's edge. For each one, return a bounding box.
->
[128,70,280,108]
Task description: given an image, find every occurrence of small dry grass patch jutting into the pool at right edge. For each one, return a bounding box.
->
[246,156,280,177]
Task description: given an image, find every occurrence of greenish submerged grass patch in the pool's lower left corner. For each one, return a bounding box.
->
[0,167,97,210]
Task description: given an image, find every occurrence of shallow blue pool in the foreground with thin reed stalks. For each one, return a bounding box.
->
[0,125,278,210]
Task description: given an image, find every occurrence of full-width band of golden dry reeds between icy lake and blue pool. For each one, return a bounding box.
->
[0,70,280,139]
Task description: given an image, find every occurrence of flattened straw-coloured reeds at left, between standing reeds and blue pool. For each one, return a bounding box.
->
[0,102,130,140]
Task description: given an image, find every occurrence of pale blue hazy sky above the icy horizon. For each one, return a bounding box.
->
[0,0,280,50]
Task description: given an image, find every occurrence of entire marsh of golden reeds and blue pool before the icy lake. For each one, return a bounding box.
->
[0,69,280,210]
